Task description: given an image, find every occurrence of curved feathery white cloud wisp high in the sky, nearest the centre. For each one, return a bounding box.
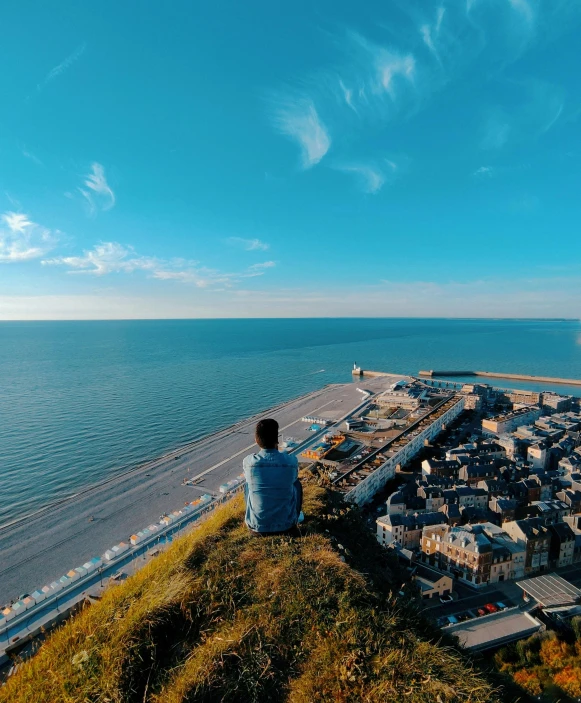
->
[274,98,331,169]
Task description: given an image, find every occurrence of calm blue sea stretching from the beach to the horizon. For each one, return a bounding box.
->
[0,319,581,524]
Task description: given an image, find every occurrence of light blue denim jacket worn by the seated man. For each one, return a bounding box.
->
[243,449,298,532]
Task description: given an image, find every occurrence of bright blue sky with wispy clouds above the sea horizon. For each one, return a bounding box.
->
[0,0,581,319]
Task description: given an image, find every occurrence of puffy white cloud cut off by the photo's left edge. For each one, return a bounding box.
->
[0,212,60,263]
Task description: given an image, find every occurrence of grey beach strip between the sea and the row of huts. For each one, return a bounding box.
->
[0,377,400,604]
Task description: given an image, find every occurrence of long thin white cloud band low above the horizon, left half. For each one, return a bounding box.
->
[42,242,276,288]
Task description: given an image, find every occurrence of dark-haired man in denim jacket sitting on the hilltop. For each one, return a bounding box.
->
[243,419,303,536]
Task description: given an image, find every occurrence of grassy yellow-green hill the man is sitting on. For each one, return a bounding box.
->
[0,485,508,703]
